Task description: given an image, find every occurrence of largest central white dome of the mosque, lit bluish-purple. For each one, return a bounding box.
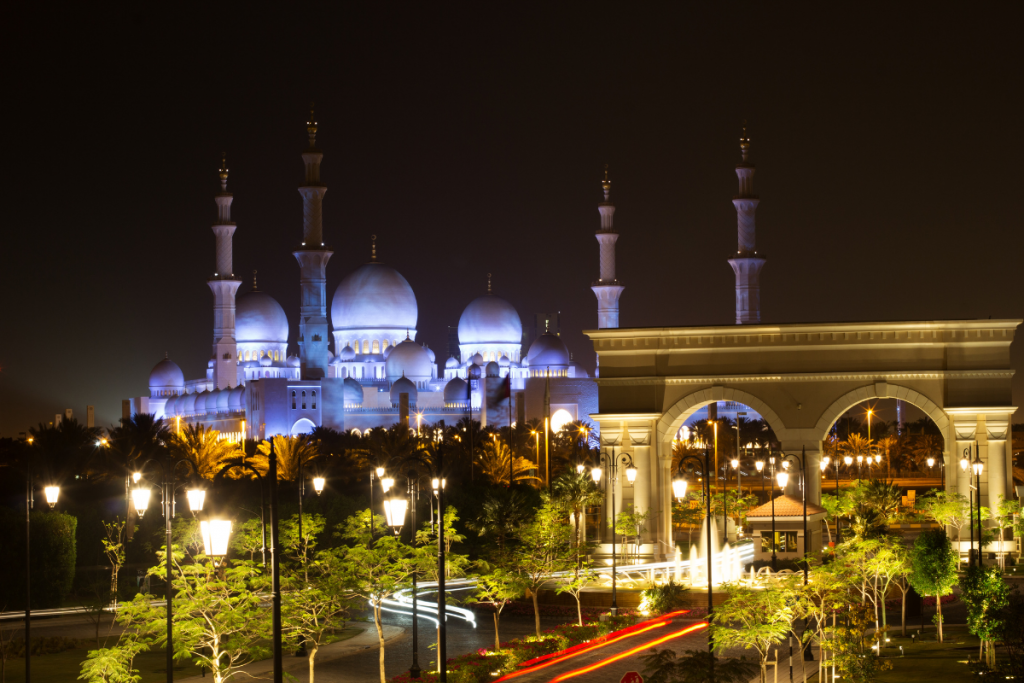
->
[331,263,418,330]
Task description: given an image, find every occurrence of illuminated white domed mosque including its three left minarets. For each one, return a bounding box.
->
[133,115,602,438]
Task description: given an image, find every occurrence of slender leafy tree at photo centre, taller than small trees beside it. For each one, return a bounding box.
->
[514,501,575,638]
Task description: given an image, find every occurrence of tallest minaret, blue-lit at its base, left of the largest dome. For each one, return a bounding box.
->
[294,109,334,380]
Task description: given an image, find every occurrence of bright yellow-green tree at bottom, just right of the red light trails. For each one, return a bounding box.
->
[711,585,794,683]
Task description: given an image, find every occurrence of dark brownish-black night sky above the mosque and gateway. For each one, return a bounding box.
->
[0,2,1024,435]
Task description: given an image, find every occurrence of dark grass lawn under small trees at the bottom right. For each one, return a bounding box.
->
[806,625,991,683]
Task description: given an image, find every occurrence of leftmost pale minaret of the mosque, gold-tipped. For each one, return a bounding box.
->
[207,155,242,389]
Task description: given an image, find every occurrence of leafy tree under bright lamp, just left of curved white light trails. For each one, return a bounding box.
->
[334,510,417,683]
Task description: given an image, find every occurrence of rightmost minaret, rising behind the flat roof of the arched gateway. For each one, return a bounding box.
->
[729,125,765,325]
